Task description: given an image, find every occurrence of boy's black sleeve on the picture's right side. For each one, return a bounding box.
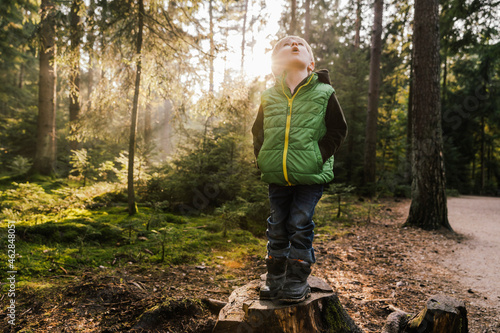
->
[318,93,347,163]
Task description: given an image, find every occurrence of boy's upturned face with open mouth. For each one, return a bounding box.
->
[273,38,314,72]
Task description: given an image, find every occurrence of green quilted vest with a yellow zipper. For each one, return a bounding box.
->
[257,73,335,186]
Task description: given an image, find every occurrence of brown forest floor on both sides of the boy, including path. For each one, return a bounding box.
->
[0,197,500,333]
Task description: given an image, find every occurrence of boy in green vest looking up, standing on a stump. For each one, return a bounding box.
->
[252,36,347,303]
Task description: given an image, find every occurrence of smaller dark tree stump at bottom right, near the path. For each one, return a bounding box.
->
[382,295,469,333]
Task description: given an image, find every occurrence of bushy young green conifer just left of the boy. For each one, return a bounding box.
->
[143,85,266,215]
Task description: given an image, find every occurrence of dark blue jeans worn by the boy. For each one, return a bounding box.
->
[266,184,323,263]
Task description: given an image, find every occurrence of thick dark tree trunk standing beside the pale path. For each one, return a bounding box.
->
[406,0,452,230]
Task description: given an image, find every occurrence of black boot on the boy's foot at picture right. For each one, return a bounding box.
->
[280,259,311,303]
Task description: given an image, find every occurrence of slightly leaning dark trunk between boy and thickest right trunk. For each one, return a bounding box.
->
[364,0,384,188]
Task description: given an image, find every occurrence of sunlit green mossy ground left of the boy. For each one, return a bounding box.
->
[0,207,265,281]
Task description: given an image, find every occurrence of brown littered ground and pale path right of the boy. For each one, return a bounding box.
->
[315,197,500,333]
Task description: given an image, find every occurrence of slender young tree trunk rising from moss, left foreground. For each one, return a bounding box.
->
[128,0,144,215]
